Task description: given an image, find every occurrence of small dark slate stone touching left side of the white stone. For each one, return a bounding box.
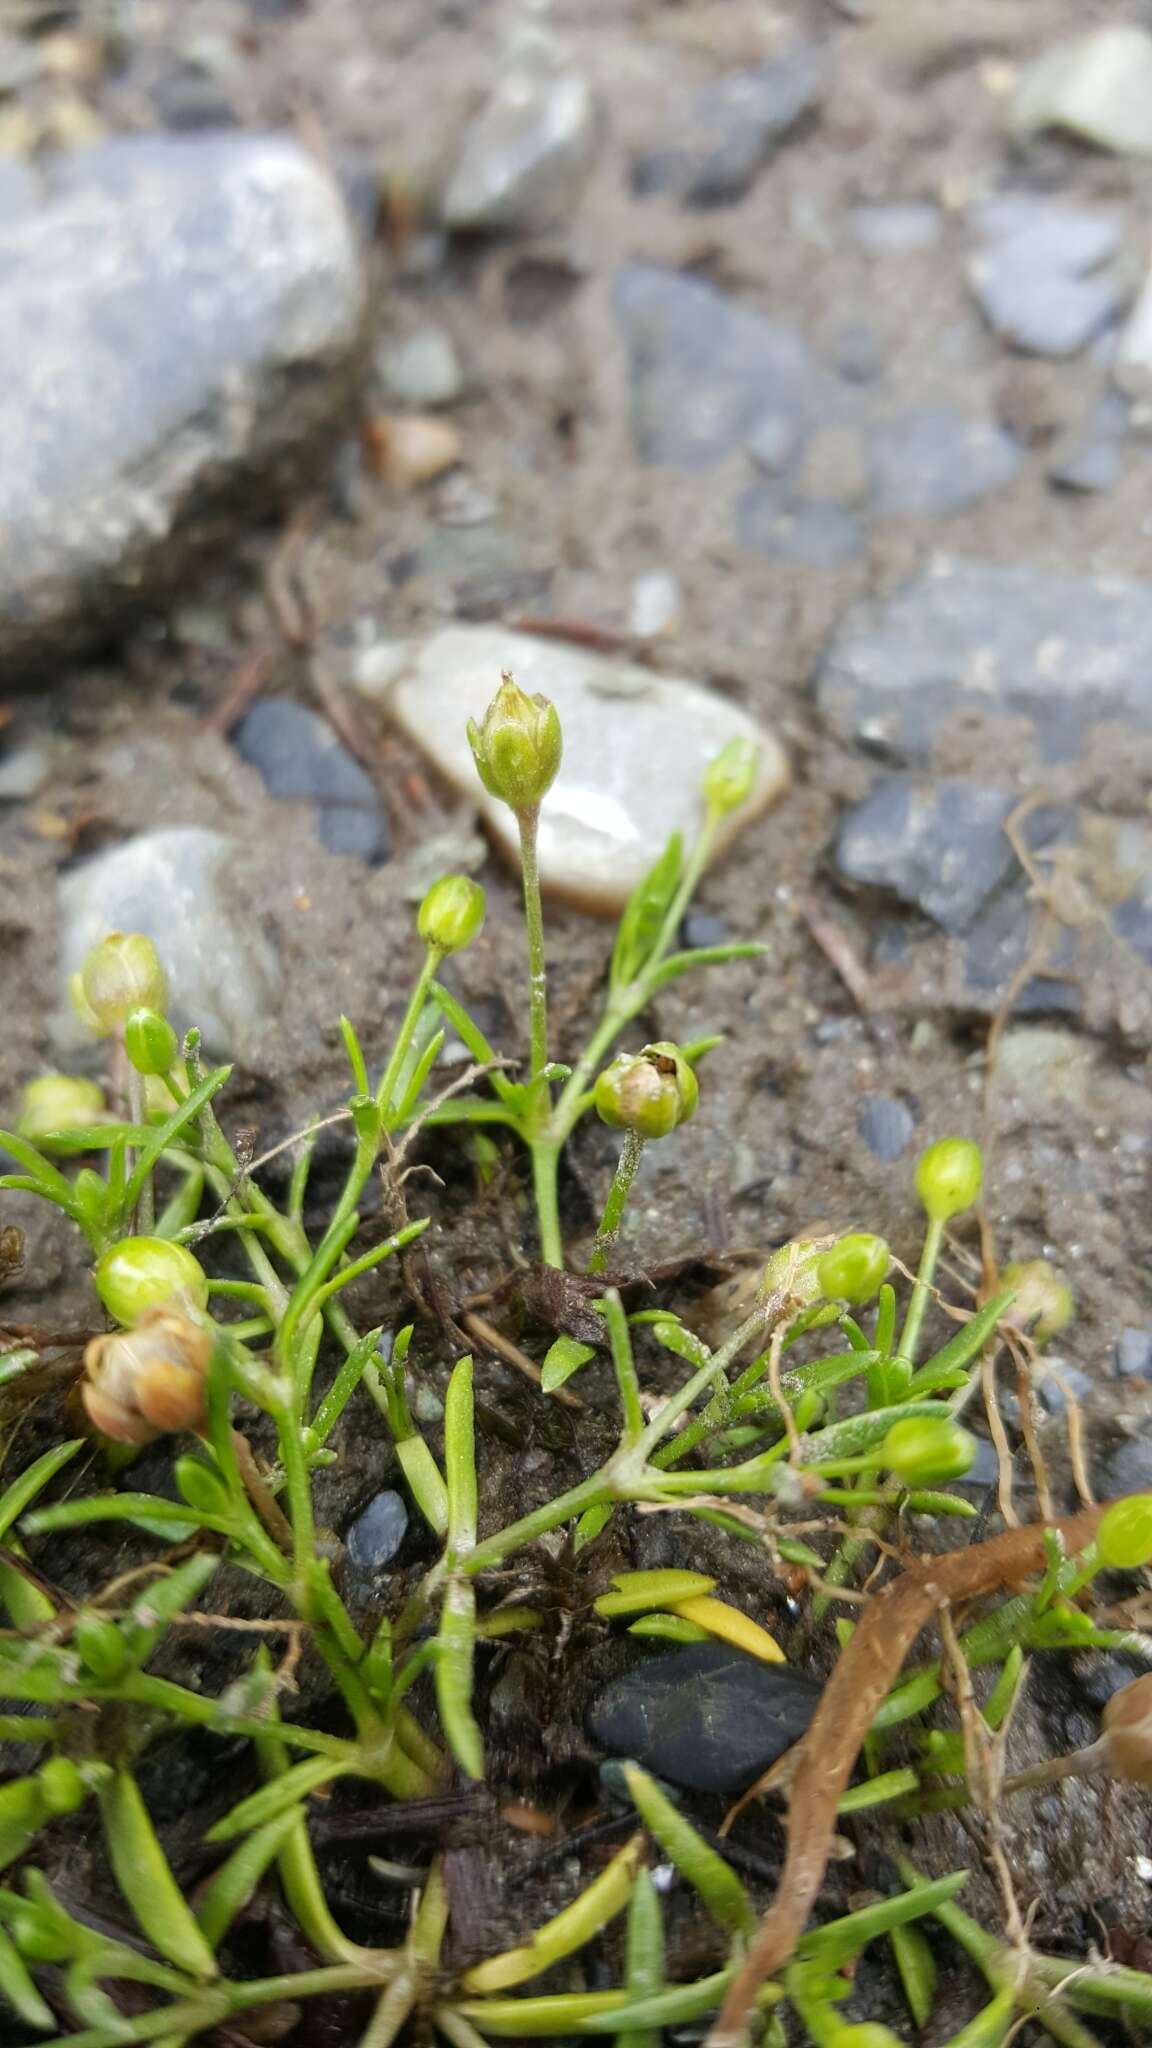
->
[234,696,389,862]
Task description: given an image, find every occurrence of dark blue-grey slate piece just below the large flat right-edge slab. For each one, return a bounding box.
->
[834,776,1017,934]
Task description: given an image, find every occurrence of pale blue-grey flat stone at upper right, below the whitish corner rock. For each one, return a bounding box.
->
[968,193,1127,356]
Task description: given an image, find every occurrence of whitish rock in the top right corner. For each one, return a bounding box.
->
[1011,23,1152,156]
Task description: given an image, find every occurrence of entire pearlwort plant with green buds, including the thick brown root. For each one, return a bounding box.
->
[0,676,1152,2048]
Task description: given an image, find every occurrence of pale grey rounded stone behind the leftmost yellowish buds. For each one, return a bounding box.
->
[53,825,281,1059]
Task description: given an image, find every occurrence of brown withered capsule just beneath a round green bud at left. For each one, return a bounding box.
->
[82,1309,213,1444]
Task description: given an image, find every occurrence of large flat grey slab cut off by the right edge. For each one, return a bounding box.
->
[816,559,1152,760]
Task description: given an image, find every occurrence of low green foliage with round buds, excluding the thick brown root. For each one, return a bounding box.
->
[0,678,1152,2048]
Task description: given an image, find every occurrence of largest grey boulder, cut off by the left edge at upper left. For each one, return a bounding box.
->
[0,133,365,674]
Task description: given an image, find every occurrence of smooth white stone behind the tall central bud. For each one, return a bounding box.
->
[366,627,787,911]
